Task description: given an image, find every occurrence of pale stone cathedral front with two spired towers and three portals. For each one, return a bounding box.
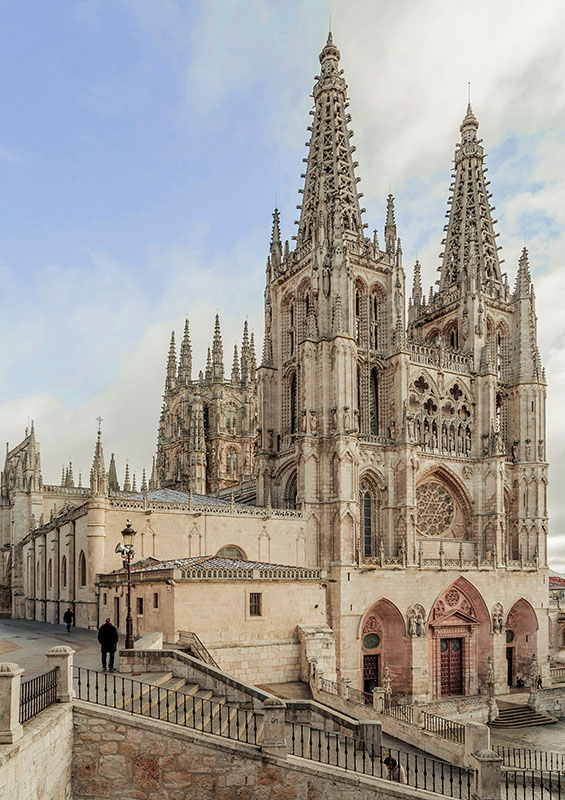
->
[256,35,548,698]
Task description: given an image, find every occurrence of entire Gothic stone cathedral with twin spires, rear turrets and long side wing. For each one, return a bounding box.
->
[0,34,551,702]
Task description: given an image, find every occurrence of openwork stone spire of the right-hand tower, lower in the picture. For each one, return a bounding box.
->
[440,104,502,295]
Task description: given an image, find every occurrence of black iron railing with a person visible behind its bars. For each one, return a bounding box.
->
[287,723,472,800]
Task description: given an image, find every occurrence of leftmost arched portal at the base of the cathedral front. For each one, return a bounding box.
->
[361,598,412,696]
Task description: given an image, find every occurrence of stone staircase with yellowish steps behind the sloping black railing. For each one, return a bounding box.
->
[83,672,263,742]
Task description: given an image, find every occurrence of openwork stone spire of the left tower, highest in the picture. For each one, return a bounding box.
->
[297,34,363,246]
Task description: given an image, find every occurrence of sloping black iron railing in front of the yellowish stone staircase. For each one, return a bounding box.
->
[74,667,260,744]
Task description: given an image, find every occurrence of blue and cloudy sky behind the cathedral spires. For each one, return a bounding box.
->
[0,0,565,569]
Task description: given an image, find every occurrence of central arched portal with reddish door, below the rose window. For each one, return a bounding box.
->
[429,578,492,697]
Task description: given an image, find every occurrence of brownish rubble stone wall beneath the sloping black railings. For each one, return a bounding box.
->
[73,701,446,800]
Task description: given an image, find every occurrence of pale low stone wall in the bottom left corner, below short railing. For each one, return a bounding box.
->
[0,703,73,800]
